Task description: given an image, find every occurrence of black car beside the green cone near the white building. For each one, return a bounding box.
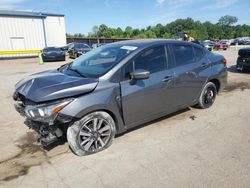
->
[42,47,65,61]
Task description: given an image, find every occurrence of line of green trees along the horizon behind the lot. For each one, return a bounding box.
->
[67,15,250,40]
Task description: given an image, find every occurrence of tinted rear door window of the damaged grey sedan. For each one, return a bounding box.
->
[173,45,195,66]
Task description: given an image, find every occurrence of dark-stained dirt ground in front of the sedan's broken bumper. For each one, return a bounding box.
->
[0,132,68,181]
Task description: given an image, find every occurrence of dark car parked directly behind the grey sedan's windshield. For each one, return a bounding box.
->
[68,43,91,59]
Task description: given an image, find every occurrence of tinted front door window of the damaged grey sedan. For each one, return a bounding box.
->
[134,46,166,73]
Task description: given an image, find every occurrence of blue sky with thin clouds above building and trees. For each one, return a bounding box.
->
[0,0,250,34]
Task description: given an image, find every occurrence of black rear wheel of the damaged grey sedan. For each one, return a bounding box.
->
[198,82,217,109]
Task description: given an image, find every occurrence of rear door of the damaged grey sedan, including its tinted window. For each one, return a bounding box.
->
[170,44,210,108]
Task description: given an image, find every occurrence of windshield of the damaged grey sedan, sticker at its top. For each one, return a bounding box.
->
[70,44,137,78]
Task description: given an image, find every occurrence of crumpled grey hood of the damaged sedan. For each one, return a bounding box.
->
[15,70,98,103]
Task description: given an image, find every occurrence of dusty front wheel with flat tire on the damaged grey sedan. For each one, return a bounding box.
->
[67,111,116,156]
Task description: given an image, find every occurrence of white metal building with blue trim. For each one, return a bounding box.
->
[0,10,66,57]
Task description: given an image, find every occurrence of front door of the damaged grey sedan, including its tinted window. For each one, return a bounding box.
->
[121,45,173,128]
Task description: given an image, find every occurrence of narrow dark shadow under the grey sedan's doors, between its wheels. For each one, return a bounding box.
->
[115,107,190,138]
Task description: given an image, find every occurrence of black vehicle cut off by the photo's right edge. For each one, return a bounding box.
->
[236,48,250,72]
